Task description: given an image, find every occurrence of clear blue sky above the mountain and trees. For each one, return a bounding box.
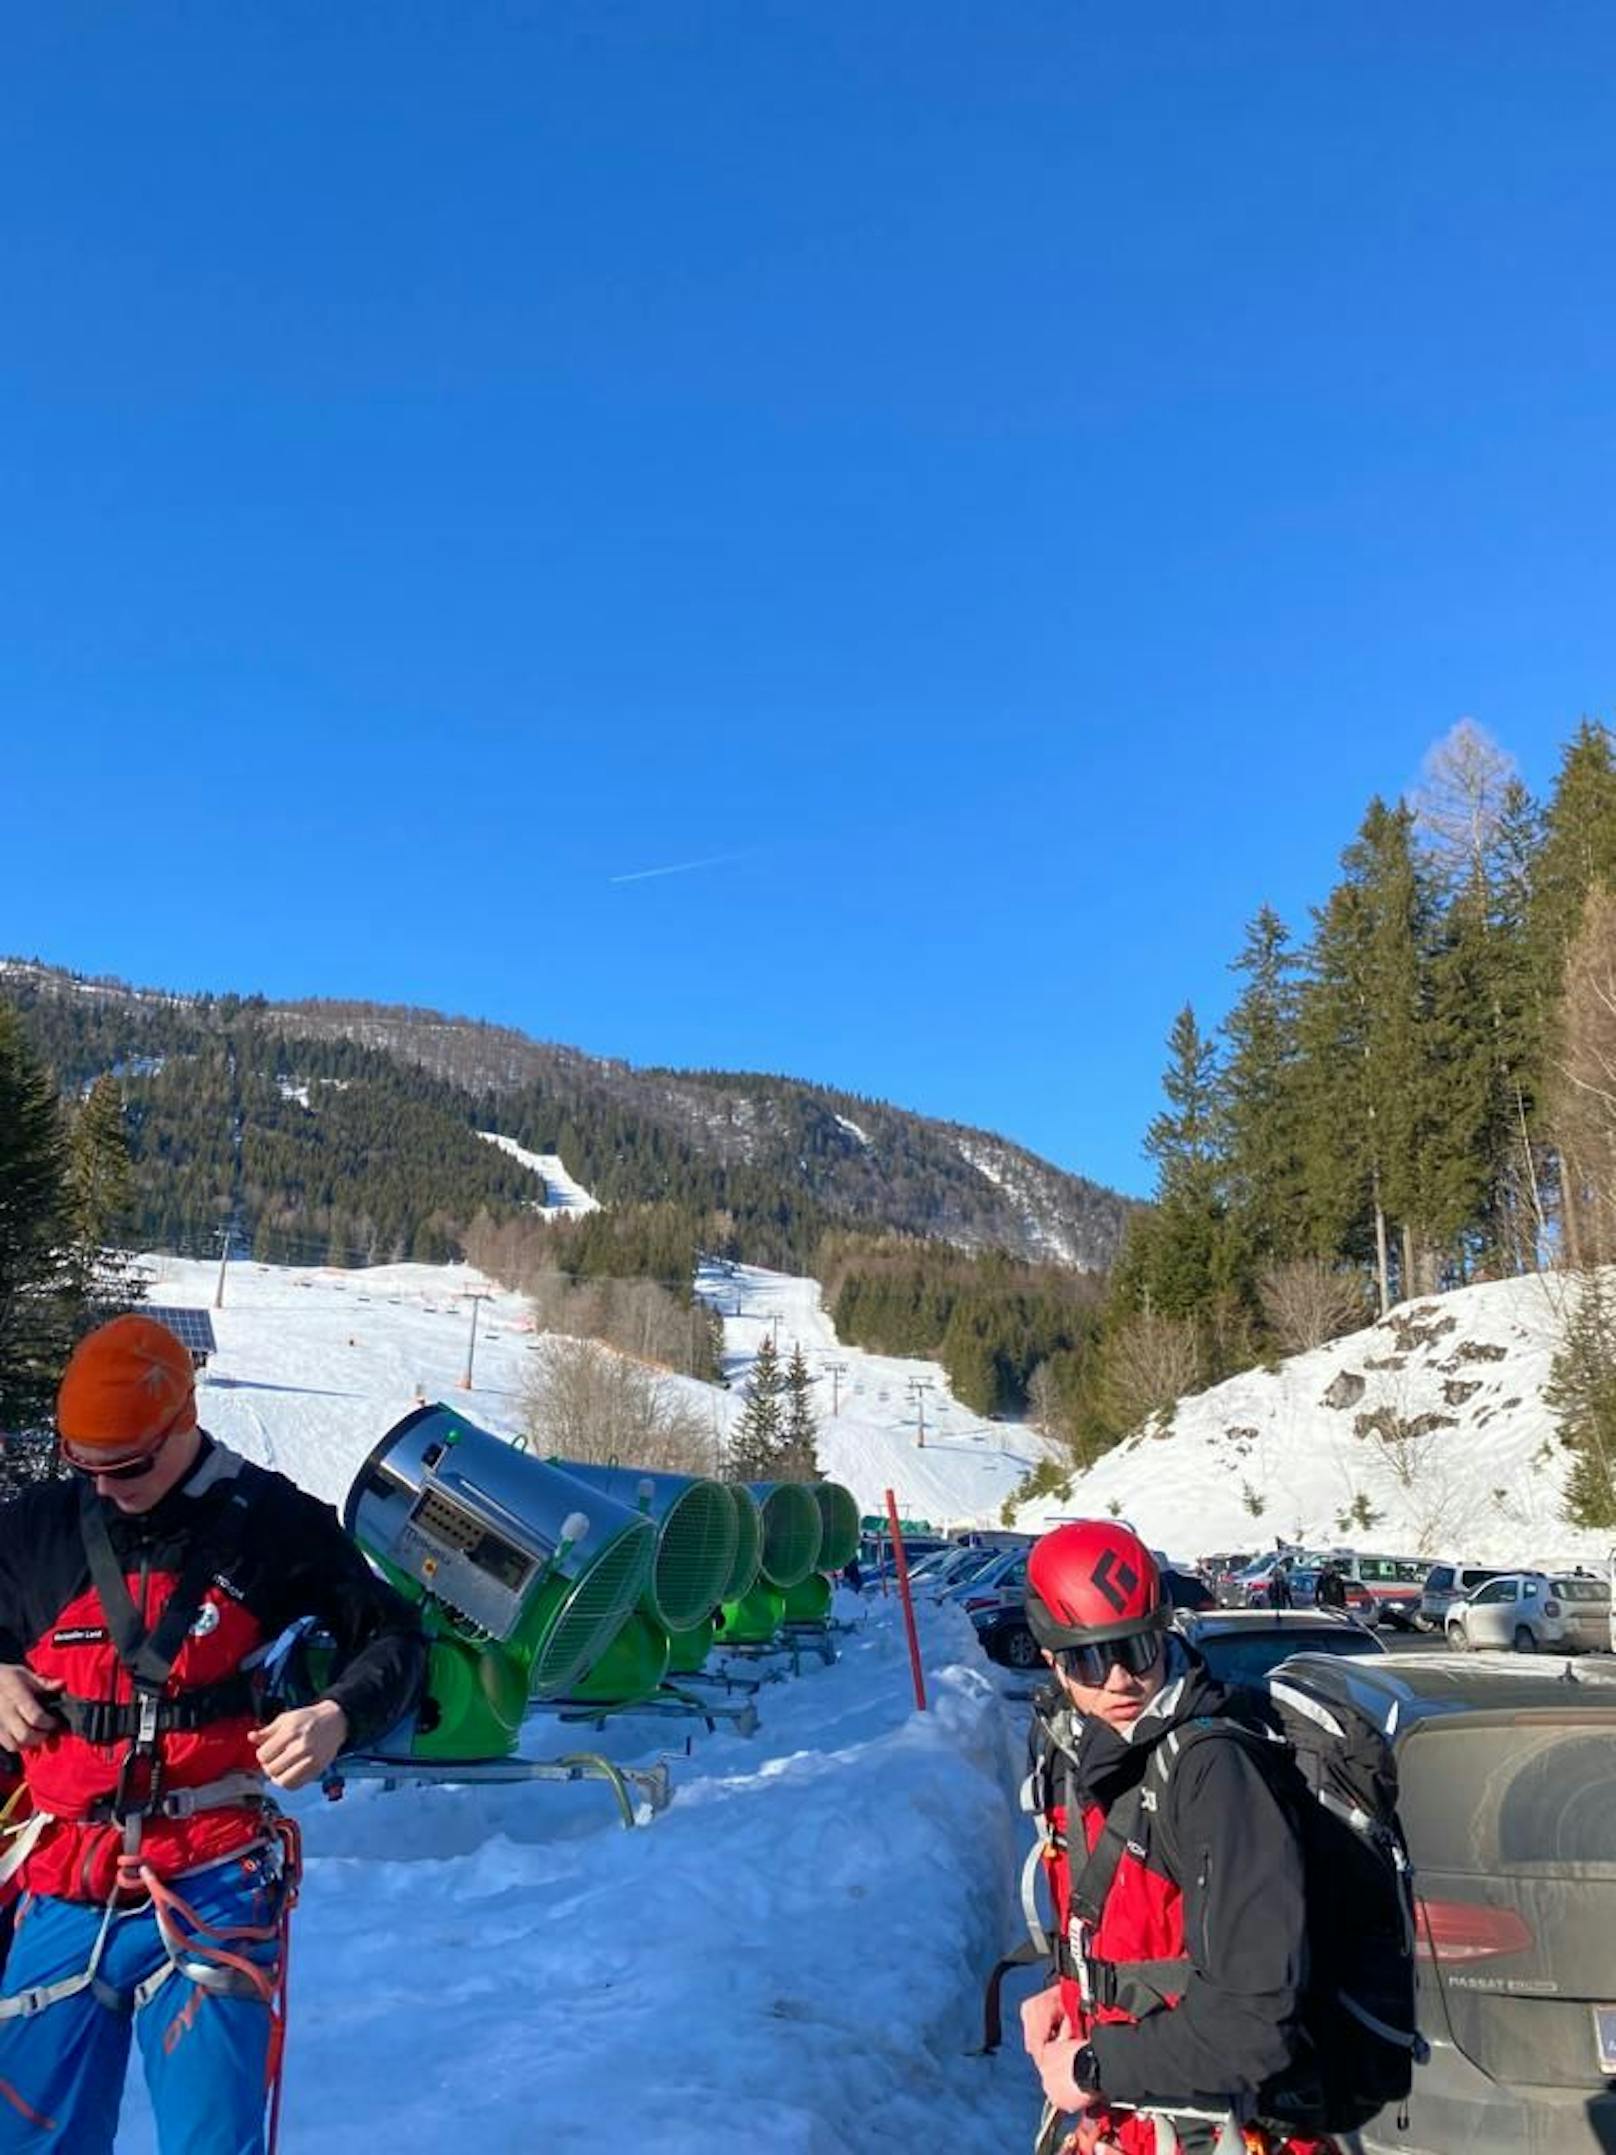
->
[0,0,1616,1190]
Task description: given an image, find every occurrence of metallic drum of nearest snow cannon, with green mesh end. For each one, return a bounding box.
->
[343,1405,657,1698]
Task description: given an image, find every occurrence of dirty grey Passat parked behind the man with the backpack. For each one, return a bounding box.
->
[1308,1655,1616,2155]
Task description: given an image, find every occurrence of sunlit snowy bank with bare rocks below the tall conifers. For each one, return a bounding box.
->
[1019,1274,1612,1565]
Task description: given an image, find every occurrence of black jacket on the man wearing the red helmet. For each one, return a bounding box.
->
[1056,1640,1308,2110]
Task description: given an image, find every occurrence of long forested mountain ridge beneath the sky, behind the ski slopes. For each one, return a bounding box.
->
[0,961,1127,1269]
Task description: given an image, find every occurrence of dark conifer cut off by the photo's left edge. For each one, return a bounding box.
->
[0,1004,71,1431]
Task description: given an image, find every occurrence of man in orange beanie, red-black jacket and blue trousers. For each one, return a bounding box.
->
[0,1315,424,2155]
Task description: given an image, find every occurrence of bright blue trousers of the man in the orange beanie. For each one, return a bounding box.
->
[0,1849,280,2155]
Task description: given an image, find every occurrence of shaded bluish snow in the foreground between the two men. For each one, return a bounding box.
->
[119,1597,1036,2155]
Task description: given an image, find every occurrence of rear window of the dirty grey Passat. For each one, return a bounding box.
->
[1398,1713,1616,1875]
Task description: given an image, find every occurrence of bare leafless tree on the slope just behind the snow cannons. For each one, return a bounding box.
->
[521,1338,718,1474]
